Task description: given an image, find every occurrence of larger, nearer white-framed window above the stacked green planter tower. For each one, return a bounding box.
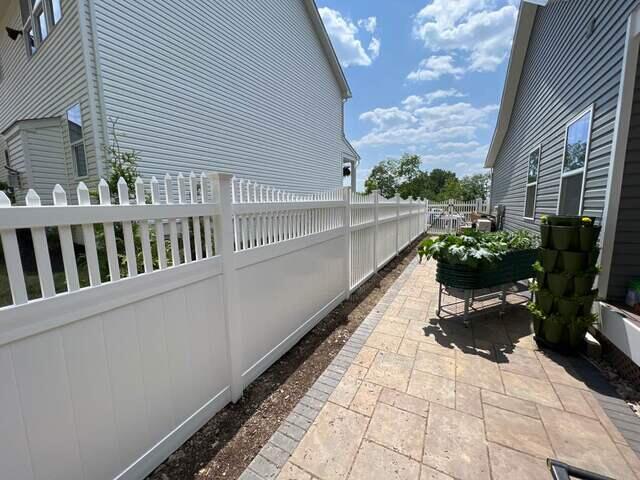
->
[558,108,592,215]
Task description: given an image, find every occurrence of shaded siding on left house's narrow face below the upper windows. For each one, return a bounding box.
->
[0,0,96,203]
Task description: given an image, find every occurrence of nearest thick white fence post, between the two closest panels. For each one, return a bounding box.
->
[208,173,244,403]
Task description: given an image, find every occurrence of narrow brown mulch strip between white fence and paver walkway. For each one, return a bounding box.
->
[148,241,418,480]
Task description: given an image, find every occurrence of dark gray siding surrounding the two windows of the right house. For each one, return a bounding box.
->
[491,0,638,229]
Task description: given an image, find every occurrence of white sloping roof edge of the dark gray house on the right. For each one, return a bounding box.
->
[484,2,538,168]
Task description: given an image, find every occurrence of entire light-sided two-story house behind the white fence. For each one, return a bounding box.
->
[0,0,358,203]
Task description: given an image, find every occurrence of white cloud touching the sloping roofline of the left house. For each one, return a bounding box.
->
[318,7,380,68]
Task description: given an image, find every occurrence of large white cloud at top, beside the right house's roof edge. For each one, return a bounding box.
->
[410,0,518,73]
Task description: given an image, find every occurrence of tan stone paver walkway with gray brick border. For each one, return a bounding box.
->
[242,262,640,480]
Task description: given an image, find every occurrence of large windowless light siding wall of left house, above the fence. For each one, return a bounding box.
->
[95,0,343,191]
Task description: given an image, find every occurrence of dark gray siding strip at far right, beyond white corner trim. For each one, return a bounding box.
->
[608,54,640,301]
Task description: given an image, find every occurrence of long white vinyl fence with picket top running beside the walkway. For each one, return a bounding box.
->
[0,174,427,480]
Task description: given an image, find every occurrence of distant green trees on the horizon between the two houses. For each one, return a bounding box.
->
[364,153,489,201]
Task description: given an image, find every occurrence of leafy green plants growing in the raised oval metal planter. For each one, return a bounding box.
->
[418,229,538,269]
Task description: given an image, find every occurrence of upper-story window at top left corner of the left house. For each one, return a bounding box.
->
[20,0,62,56]
